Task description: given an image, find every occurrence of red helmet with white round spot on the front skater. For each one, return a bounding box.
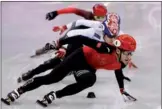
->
[114,34,136,51]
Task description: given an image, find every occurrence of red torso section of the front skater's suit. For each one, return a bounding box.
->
[83,46,121,70]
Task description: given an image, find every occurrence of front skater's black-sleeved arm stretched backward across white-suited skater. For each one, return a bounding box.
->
[59,36,115,53]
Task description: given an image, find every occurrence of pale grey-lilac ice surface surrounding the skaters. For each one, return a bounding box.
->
[1,2,161,109]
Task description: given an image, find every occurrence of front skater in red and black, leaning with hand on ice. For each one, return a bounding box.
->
[1,34,136,106]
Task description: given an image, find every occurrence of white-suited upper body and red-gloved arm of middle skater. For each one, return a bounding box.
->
[53,20,98,37]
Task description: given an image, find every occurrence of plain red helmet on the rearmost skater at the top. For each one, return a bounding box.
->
[93,4,107,16]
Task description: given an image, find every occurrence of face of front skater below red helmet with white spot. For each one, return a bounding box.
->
[120,51,132,65]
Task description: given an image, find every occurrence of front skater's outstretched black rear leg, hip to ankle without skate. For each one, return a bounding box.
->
[6,49,90,102]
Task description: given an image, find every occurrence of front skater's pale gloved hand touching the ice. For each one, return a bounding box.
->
[120,88,137,102]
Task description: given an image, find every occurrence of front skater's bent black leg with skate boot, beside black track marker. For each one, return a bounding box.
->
[40,70,96,104]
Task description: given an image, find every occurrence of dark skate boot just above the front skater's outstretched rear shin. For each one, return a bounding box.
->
[17,71,33,83]
